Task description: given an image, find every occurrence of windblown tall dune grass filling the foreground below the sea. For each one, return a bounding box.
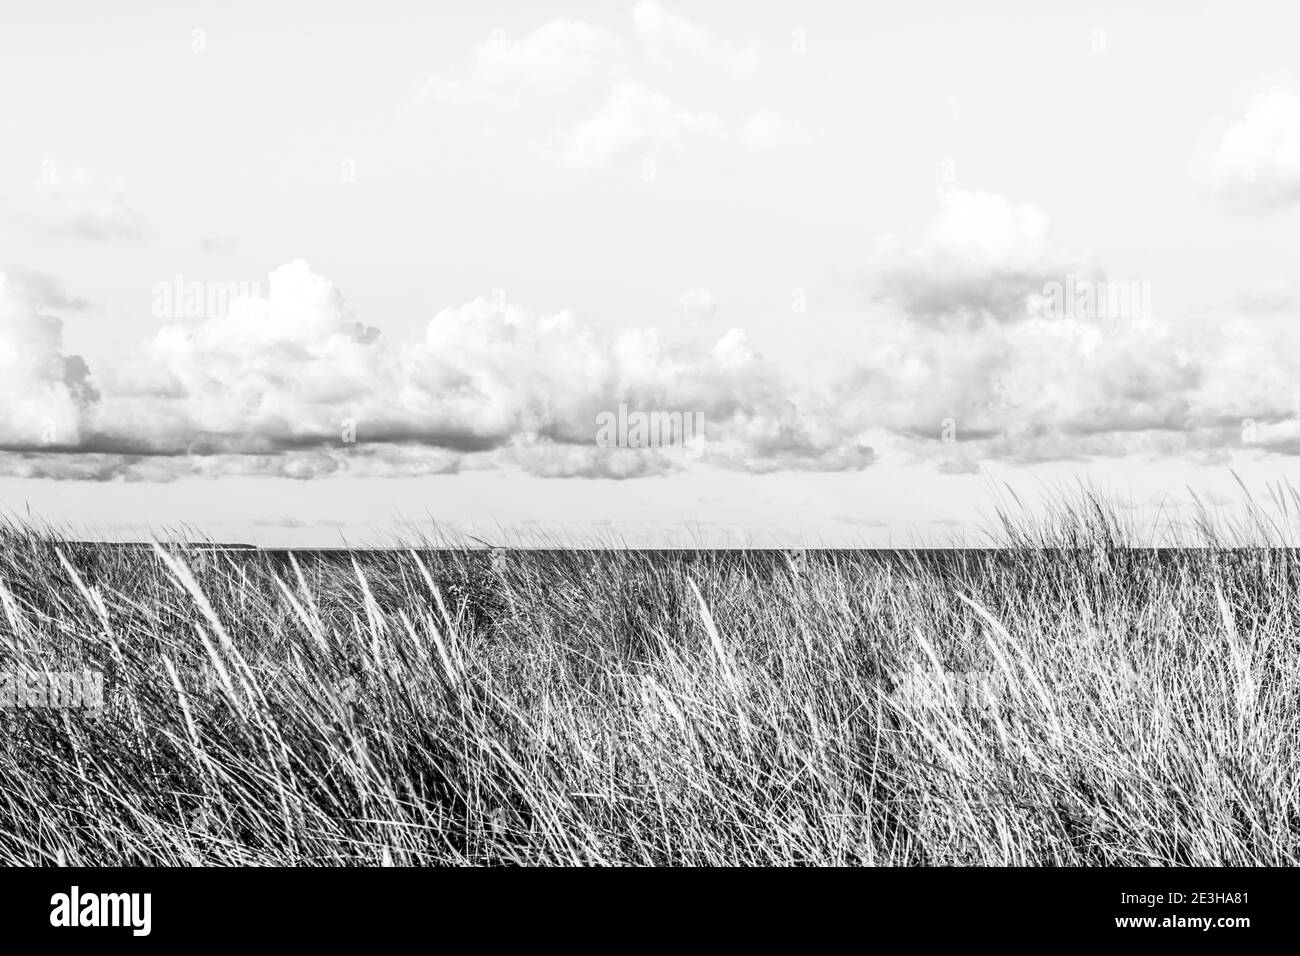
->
[0,497,1300,865]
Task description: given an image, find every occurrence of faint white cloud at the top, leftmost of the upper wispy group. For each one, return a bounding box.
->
[421,20,623,108]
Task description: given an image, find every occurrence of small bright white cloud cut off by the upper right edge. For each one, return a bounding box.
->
[1192,85,1300,208]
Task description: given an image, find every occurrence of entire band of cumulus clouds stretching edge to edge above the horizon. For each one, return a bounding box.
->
[15,185,1300,480]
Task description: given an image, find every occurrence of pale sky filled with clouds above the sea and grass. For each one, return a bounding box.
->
[0,0,1300,546]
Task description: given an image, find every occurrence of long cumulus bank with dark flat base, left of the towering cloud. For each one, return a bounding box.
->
[12,260,852,480]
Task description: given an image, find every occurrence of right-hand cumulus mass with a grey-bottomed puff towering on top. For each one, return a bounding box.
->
[831,190,1300,471]
